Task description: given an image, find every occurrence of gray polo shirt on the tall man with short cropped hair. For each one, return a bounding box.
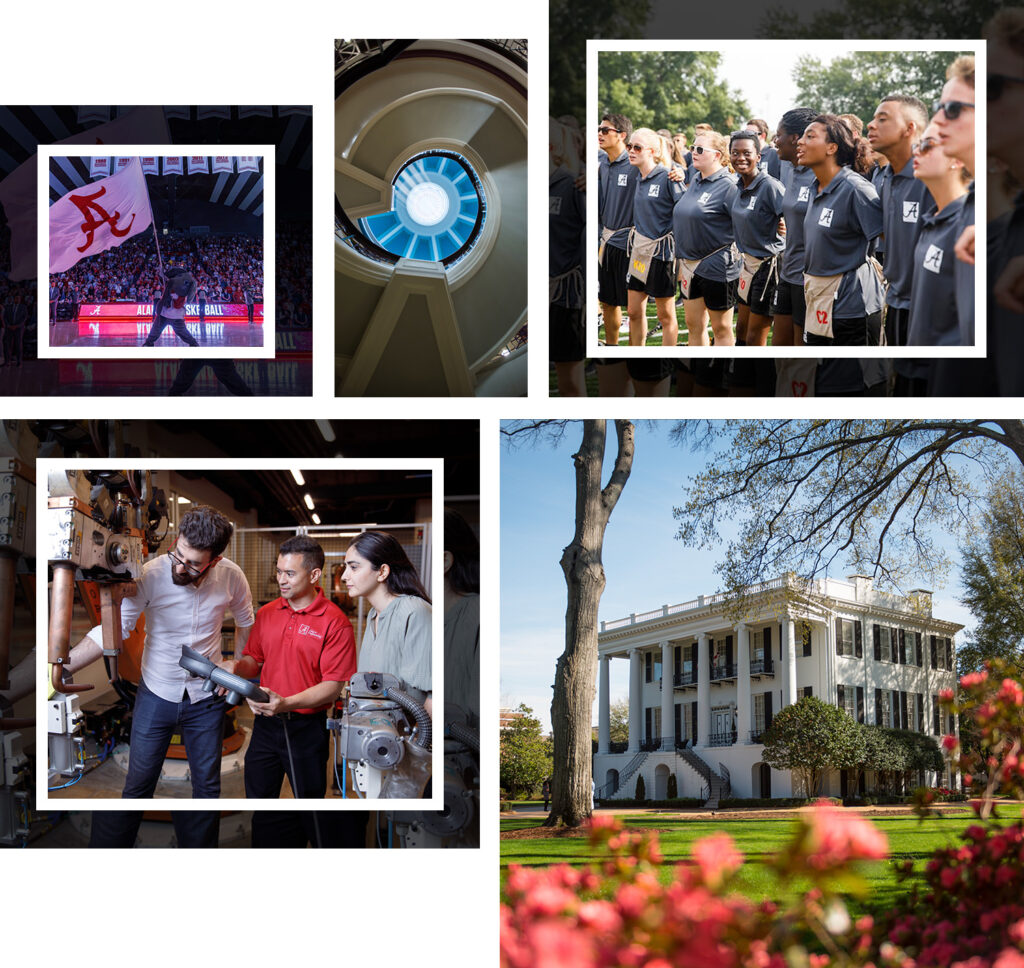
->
[874,158,935,309]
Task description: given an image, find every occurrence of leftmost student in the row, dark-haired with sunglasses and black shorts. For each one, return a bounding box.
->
[597,115,638,346]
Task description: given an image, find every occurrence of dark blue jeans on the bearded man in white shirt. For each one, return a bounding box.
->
[89,682,224,847]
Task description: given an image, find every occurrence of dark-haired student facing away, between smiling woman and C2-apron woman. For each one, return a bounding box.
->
[772,108,819,346]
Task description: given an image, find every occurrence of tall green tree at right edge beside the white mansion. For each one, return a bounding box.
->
[956,472,1024,675]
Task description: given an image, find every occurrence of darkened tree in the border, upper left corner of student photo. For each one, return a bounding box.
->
[548,0,650,119]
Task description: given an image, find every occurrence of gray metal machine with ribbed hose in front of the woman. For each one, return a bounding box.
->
[327,672,431,799]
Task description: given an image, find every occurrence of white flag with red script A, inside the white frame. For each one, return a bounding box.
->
[50,158,153,272]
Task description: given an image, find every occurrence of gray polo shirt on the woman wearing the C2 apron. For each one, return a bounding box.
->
[804,168,883,319]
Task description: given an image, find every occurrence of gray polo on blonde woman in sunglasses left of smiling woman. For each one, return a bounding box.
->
[672,168,739,283]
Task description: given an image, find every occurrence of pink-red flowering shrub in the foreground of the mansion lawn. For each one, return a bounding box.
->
[501,666,1024,968]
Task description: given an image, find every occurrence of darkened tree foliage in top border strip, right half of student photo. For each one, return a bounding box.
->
[760,0,1004,40]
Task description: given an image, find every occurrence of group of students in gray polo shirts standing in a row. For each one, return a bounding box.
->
[550,50,975,395]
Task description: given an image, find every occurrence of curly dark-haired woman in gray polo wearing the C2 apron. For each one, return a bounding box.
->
[797,115,883,348]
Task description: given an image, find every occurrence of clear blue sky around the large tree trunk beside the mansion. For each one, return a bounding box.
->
[501,421,974,730]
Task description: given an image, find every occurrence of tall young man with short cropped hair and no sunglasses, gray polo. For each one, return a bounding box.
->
[867,94,934,366]
